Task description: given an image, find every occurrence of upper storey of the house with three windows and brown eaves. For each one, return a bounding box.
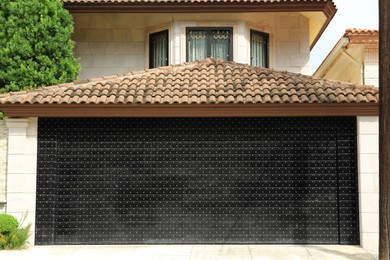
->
[64,1,336,80]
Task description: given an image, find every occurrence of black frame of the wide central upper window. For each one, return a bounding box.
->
[186,26,234,62]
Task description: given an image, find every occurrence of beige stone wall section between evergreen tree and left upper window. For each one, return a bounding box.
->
[73,14,145,80]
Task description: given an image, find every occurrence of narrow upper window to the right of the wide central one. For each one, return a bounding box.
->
[250,30,269,68]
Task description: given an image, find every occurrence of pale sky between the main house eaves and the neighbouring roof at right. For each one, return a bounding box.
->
[310,0,379,73]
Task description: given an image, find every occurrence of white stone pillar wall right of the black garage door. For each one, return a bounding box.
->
[357,117,379,253]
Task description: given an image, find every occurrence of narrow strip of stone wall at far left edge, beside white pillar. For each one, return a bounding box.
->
[0,120,8,213]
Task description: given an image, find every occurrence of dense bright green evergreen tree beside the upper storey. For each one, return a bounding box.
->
[0,0,80,93]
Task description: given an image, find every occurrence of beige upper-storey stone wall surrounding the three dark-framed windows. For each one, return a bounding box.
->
[73,13,310,80]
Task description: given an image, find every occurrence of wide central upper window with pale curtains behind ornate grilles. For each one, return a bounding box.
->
[187,27,233,61]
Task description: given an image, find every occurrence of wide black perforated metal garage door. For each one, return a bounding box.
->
[36,117,359,244]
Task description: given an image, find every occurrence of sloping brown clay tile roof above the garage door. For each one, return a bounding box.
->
[0,59,379,104]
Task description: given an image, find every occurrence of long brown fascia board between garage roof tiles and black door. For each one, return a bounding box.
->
[0,103,379,117]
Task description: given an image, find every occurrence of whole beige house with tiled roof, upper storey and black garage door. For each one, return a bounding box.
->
[0,0,378,251]
